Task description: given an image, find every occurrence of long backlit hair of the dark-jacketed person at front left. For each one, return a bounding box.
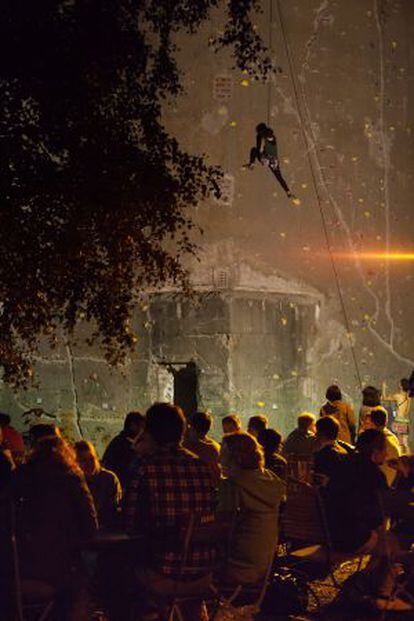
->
[28,435,83,477]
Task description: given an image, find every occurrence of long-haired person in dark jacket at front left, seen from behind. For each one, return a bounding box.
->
[11,433,98,621]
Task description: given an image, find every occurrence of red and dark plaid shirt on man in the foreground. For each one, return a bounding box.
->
[125,447,216,578]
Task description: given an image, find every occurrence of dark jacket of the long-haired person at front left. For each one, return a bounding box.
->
[11,463,97,587]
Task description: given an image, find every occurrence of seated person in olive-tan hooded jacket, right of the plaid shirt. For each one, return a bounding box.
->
[217,432,285,584]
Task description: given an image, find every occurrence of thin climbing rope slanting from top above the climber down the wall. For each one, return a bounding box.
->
[274,0,362,389]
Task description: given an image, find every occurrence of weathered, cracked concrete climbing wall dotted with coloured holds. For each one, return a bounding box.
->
[0,0,414,444]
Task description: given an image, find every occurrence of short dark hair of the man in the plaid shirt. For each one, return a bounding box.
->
[145,403,186,446]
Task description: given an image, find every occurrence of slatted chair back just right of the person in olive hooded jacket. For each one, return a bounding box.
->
[281,478,329,546]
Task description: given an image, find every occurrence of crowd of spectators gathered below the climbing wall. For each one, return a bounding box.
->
[0,386,414,621]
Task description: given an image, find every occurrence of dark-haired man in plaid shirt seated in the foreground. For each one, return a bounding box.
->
[125,403,216,621]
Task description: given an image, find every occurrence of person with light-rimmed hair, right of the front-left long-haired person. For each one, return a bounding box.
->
[75,440,122,530]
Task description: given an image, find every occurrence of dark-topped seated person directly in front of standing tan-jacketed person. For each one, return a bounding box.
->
[313,415,348,478]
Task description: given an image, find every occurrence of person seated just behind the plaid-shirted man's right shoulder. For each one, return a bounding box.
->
[184,412,220,485]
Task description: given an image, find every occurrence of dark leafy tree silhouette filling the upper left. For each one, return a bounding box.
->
[0,0,271,386]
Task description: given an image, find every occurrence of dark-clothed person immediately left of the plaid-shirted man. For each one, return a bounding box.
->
[102,412,145,490]
